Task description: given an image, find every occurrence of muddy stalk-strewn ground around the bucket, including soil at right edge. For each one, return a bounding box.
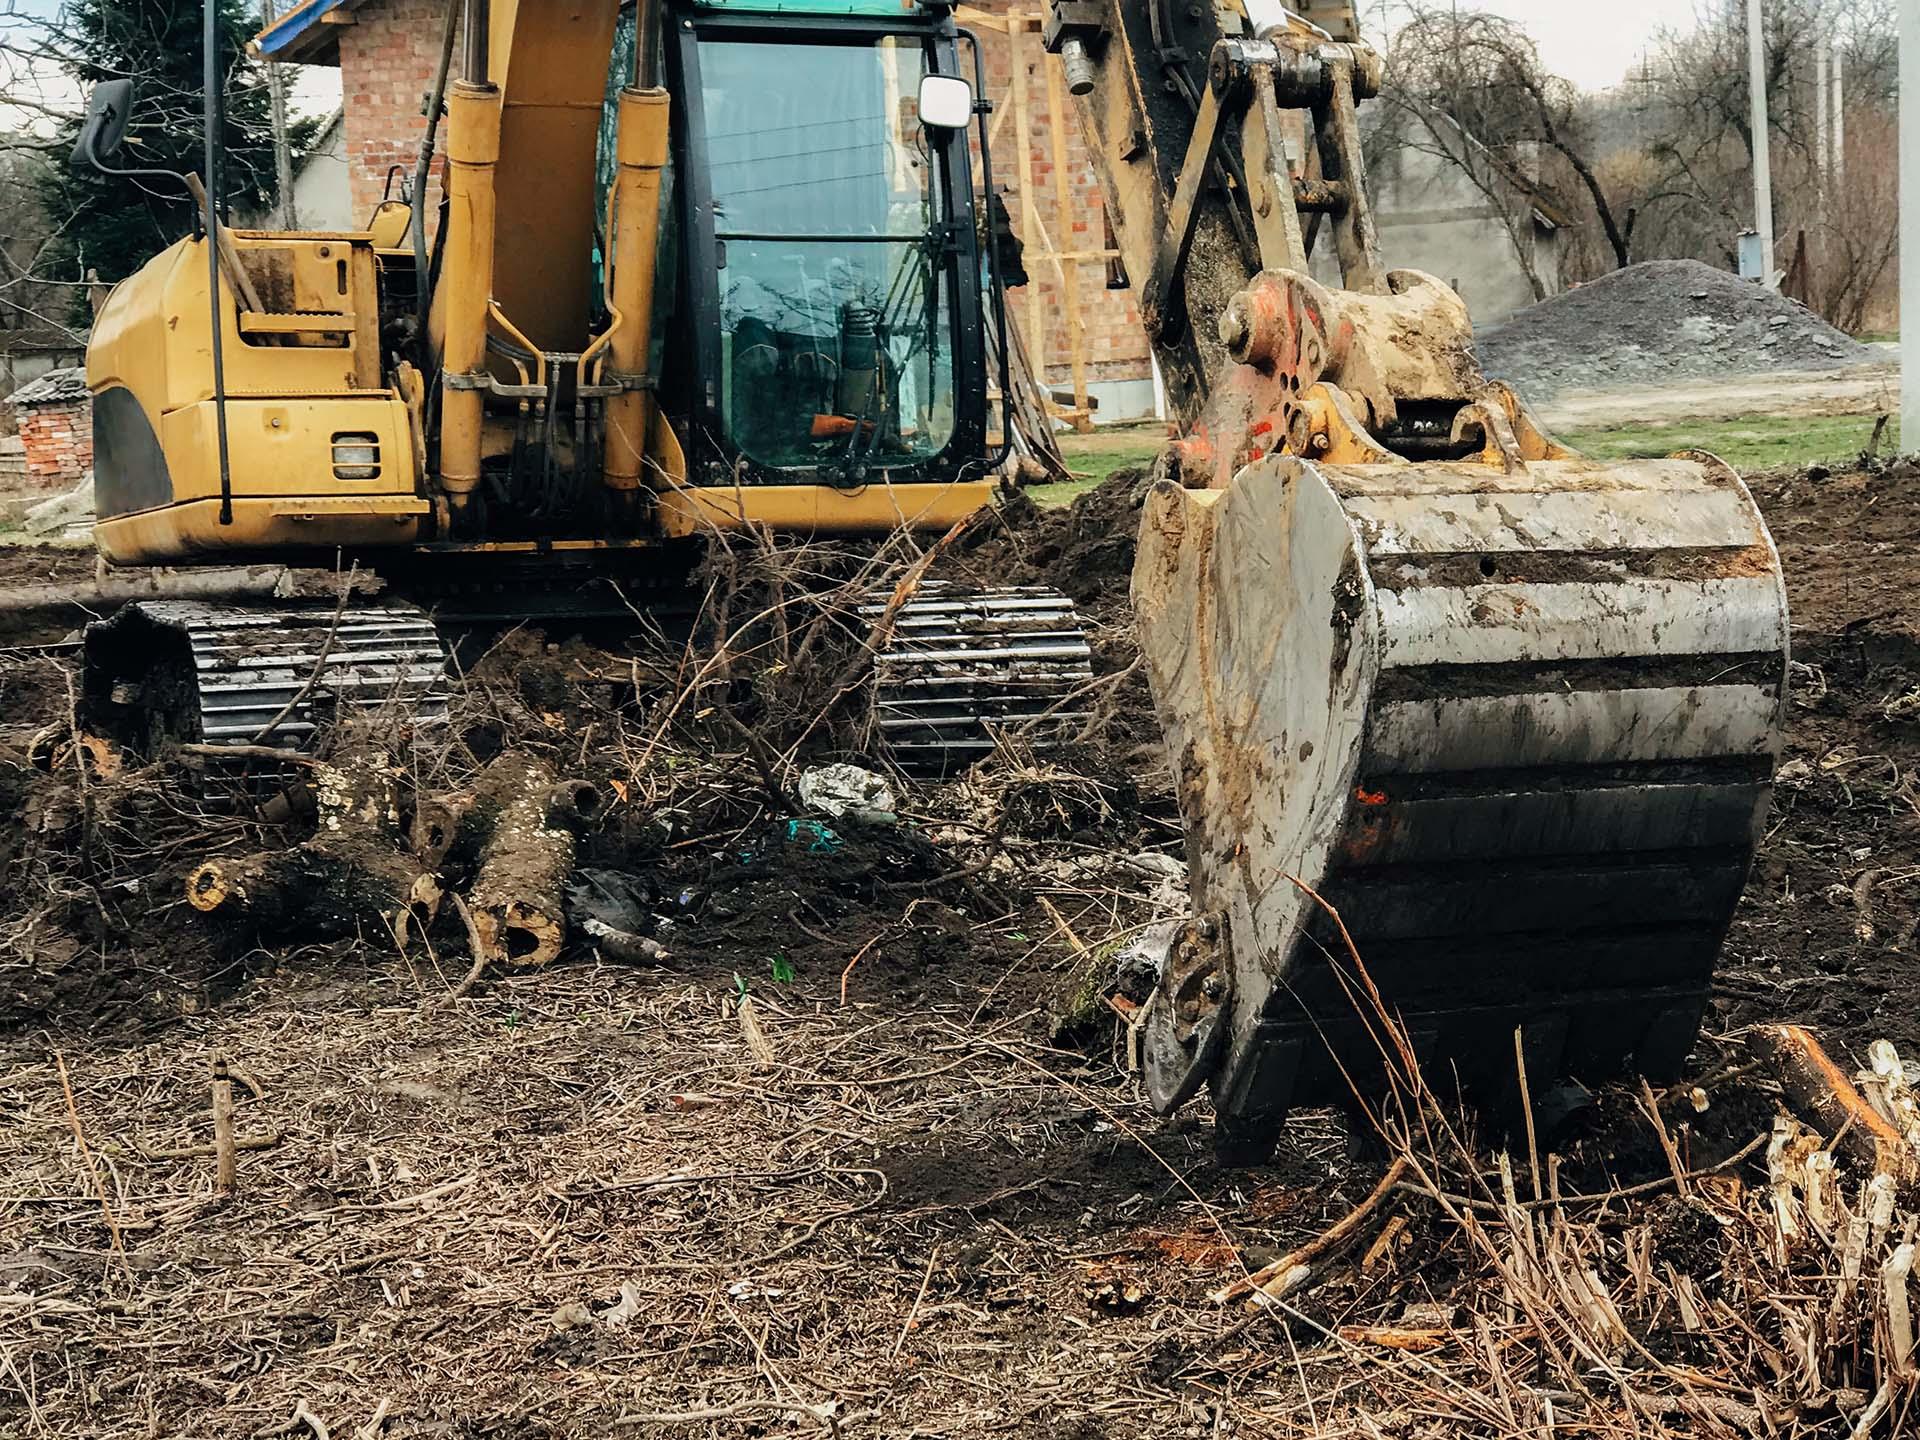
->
[0,458,1920,1440]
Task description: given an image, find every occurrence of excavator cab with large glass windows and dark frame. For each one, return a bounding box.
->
[670,8,991,488]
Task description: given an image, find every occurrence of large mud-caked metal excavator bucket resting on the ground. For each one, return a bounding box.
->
[1133,455,1788,1162]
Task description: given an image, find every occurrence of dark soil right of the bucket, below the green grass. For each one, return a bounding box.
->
[1716,465,1920,1058]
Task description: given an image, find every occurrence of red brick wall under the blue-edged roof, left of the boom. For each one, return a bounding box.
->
[340,0,459,225]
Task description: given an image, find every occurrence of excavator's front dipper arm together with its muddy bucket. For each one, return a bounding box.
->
[1044,0,1788,1162]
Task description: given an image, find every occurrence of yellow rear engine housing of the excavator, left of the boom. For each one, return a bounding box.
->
[86,230,430,564]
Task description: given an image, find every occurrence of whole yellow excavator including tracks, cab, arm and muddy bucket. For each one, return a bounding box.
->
[79,0,1788,1164]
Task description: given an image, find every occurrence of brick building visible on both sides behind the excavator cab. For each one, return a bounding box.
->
[255,0,1156,420]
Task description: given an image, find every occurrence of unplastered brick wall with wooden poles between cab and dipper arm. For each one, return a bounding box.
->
[975,0,1152,390]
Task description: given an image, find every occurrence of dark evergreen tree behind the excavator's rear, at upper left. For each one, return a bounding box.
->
[40,0,315,319]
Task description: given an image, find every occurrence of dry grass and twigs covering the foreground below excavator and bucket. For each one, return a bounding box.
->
[0,533,1920,1440]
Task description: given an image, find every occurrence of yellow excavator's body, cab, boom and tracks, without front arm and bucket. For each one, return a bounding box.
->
[75,0,1091,764]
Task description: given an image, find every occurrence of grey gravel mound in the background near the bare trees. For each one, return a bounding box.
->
[1475,259,1880,401]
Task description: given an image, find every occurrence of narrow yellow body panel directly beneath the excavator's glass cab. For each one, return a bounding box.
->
[659,480,995,536]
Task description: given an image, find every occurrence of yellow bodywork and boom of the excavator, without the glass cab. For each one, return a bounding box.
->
[88,9,993,564]
